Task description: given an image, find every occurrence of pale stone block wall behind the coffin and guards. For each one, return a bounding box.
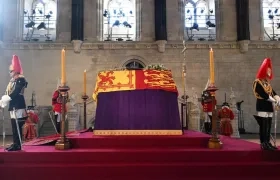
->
[0,0,280,135]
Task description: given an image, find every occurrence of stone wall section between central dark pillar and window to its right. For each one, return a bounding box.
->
[166,0,185,41]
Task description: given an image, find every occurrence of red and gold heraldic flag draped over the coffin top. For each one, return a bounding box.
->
[93,70,178,100]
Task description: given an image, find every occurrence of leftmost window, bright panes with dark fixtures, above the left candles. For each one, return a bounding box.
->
[23,0,57,41]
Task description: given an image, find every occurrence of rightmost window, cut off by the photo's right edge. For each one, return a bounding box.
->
[262,0,280,41]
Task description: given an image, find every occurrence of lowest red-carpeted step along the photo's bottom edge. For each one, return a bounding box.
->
[0,162,280,180]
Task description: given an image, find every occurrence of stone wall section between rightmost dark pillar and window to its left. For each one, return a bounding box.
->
[215,0,237,41]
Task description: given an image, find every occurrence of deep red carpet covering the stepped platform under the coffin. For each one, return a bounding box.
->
[0,131,280,180]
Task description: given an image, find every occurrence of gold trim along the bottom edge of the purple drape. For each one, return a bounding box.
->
[93,130,183,136]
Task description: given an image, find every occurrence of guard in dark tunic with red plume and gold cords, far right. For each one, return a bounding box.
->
[253,58,280,150]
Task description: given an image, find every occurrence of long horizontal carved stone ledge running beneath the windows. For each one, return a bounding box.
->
[0,40,280,50]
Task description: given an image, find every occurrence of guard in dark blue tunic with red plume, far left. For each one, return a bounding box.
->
[1,55,28,151]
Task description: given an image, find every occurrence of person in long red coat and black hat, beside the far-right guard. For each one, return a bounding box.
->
[218,102,234,137]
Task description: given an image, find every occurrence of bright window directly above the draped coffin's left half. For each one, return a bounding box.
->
[103,0,136,41]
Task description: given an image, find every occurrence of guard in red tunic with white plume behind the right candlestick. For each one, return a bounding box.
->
[201,80,216,134]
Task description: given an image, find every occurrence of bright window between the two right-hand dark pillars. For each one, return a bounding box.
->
[184,0,216,40]
